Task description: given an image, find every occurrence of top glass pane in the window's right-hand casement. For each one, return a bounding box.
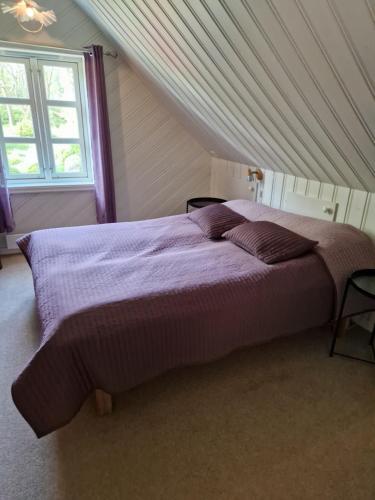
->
[43,66,76,101]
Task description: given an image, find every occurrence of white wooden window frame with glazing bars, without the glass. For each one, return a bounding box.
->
[0,47,94,190]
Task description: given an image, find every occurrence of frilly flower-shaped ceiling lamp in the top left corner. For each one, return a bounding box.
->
[1,0,56,33]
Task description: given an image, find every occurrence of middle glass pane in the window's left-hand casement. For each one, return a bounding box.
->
[0,104,34,137]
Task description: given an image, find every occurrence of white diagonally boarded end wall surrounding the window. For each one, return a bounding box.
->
[0,0,210,233]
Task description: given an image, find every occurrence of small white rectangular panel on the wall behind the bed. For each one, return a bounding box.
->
[283,191,338,221]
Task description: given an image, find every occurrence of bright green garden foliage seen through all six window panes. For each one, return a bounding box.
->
[0,61,81,176]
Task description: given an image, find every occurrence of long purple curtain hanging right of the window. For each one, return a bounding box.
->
[85,45,116,224]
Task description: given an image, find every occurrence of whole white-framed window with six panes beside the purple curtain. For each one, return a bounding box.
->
[0,49,92,187]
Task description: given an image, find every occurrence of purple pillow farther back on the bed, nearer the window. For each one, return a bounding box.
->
[188,204,247,238]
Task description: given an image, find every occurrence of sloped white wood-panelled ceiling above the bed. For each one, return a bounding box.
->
[77,0,375,191]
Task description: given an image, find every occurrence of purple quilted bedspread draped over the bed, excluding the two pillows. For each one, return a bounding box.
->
[12,200,375,437]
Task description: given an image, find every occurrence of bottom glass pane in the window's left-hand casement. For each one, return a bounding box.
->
[5,143,40,175]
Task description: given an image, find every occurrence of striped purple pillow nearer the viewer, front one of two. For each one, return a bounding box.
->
[223,221,318,264]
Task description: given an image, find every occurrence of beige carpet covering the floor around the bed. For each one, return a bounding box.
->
[0,256,375,500]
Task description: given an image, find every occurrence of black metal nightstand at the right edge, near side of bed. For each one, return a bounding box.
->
[329,269,375,364]
